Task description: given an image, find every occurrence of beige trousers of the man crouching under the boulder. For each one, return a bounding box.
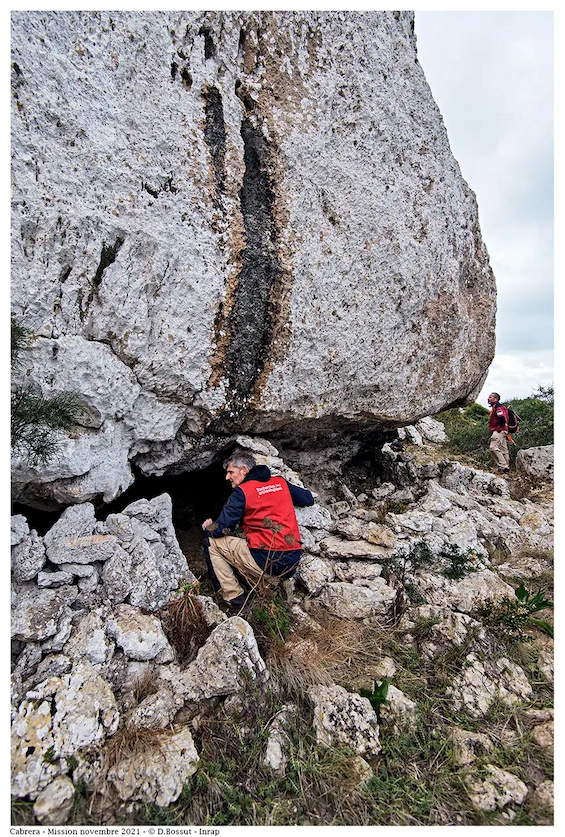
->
[208,535,278,602]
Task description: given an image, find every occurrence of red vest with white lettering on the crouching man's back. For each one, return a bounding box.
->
[239,477,302,552]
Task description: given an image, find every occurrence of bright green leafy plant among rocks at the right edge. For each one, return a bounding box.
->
[476,582,553,642]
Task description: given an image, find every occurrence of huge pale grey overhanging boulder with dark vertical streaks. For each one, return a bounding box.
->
[12,11,495,504]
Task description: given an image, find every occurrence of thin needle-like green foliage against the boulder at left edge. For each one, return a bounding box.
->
[11,317,82,466]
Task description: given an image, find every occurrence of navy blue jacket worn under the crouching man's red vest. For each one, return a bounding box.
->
[208,465,314,577]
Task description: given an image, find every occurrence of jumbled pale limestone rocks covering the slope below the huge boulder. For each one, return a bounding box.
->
[12,419,553,825]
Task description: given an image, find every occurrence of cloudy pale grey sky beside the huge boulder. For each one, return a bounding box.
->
[415,11,554,404]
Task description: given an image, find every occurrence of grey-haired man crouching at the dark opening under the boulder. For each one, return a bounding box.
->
[202,452,314,610]
